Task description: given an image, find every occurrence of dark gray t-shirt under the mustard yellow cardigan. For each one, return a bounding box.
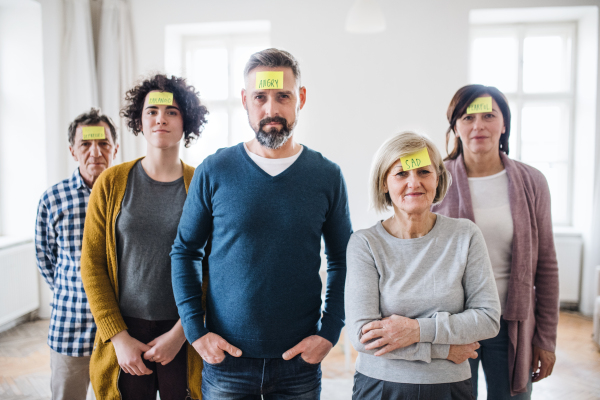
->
[116,161,186,321]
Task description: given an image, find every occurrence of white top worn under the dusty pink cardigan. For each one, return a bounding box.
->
[469,170,514,313]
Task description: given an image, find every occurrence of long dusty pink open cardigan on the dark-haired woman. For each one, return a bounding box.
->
[432,152,558,396]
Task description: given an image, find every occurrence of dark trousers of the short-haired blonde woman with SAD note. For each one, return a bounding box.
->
[352,372,473,400]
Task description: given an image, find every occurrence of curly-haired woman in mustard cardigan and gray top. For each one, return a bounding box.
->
[81,75,208,400]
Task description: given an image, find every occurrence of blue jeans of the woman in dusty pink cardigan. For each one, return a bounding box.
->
[469,318,531,400]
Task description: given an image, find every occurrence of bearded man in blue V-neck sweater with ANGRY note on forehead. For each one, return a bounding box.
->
[171,49,352,399]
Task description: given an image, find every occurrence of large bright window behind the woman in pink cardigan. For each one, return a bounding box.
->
[470,23,576,225]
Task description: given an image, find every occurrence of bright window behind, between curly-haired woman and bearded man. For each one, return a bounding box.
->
[181,33,269,166]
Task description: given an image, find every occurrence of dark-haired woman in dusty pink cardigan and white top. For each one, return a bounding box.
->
[432,85,558,400]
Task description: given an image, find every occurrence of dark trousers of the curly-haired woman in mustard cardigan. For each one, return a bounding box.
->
[119,317,187,400]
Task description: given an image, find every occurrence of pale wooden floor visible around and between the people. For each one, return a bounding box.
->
[0,312,600,400]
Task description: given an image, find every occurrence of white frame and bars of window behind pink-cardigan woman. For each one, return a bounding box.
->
[469,21,578,226]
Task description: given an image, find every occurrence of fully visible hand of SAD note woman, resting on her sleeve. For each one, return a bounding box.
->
[360,315,421,356]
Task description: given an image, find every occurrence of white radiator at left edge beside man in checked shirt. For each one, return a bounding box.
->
[0,241,40,326]
